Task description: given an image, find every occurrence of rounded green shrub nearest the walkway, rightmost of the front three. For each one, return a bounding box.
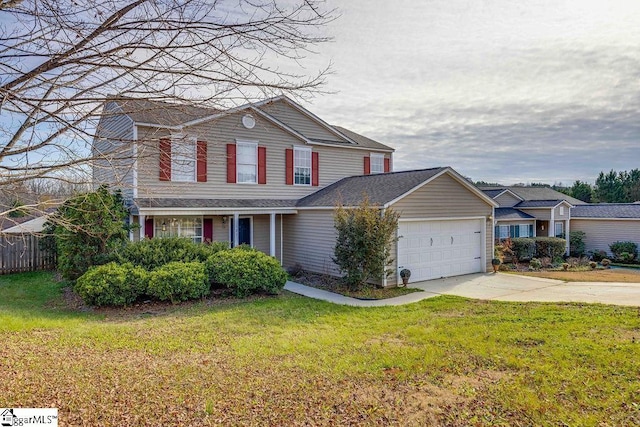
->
[206,247,287,298]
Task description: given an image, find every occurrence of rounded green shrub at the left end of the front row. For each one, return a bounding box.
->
[74,262,148,306]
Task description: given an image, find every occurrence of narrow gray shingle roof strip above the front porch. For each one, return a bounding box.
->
[134,198,297,208]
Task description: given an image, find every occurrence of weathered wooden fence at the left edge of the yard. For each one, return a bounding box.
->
[0,234,56,274]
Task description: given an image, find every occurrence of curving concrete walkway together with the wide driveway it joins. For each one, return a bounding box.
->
[284,273,640,307]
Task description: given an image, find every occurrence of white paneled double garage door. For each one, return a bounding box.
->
[398,219,484,282]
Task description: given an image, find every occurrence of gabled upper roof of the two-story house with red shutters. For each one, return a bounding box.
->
[110,95,395,152]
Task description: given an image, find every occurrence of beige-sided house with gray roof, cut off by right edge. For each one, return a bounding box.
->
[571,203,640,254]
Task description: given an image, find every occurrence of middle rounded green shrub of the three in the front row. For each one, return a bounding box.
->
[147,262,209,302]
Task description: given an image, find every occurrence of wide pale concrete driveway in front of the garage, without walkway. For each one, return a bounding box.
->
[411,273,640,306]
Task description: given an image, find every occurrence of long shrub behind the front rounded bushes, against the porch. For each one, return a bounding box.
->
[119,237,229,270]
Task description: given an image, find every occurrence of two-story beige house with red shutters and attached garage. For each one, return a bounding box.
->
[93,96,498,284]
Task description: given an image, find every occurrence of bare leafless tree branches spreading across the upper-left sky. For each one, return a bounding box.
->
[0,0,334,219]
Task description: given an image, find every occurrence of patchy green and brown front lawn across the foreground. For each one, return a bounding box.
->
[0,273,640,426]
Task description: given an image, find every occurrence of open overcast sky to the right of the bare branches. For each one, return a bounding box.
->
[306,0,640,184]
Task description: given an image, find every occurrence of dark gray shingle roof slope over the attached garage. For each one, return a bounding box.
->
[298,168,447,207]
